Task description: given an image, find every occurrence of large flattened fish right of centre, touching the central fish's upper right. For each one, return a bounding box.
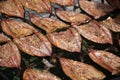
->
[74,21,113,44]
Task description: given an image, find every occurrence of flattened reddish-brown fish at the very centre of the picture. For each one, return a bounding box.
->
[47,28,82,52]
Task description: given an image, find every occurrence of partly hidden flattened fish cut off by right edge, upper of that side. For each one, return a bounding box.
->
[100,17,120,32]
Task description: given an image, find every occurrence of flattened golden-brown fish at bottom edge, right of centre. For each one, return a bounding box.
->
[59,58,105,80]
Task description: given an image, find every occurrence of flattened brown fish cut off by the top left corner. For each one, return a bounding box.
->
[0,0,24,18]
